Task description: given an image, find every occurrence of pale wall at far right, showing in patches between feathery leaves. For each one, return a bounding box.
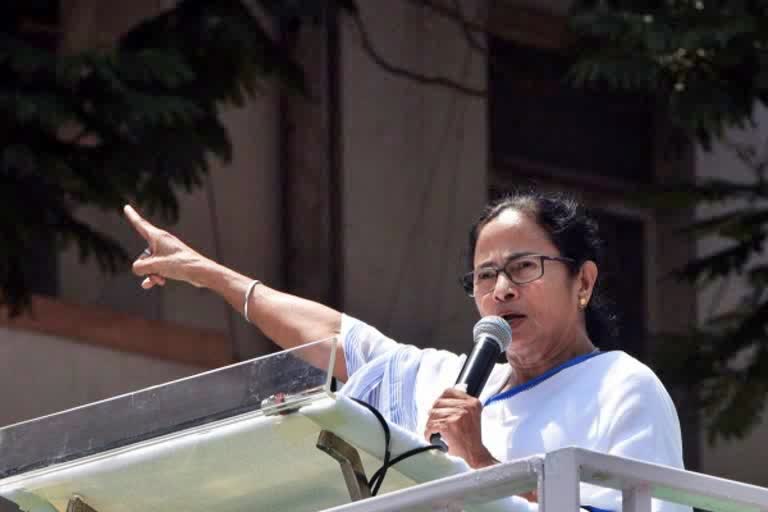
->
[696,104,768,486]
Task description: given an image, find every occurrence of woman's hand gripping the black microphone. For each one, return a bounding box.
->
[424,388,499,469]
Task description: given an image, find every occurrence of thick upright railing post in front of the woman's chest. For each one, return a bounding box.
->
[540,449,579,512]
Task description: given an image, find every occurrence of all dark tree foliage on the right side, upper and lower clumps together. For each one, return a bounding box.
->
[571,0,768,442]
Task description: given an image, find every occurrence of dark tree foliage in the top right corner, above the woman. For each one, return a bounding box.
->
[571,0,768,149]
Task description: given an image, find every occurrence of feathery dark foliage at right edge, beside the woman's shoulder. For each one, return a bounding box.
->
[640,143,768,443]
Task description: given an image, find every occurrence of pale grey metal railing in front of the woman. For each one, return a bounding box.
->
[324,448,768,512]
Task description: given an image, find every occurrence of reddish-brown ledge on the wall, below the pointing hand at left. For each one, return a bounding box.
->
[0,296,234,368]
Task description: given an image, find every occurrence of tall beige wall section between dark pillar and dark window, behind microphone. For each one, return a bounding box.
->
[341,0,487,351]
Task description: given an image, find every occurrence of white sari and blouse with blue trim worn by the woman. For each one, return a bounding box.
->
[341,315,690,512]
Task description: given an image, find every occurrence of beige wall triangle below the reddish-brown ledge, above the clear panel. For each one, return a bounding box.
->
[0,328,202,426]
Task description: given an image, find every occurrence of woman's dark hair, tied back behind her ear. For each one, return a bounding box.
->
[467,190,618,345]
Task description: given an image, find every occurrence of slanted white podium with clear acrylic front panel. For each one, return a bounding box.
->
[0,339,514,512]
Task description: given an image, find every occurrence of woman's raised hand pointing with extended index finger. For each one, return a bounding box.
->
[123,205,206,289]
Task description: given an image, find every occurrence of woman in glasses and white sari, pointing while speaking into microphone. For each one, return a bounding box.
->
[126,193,683,510]
